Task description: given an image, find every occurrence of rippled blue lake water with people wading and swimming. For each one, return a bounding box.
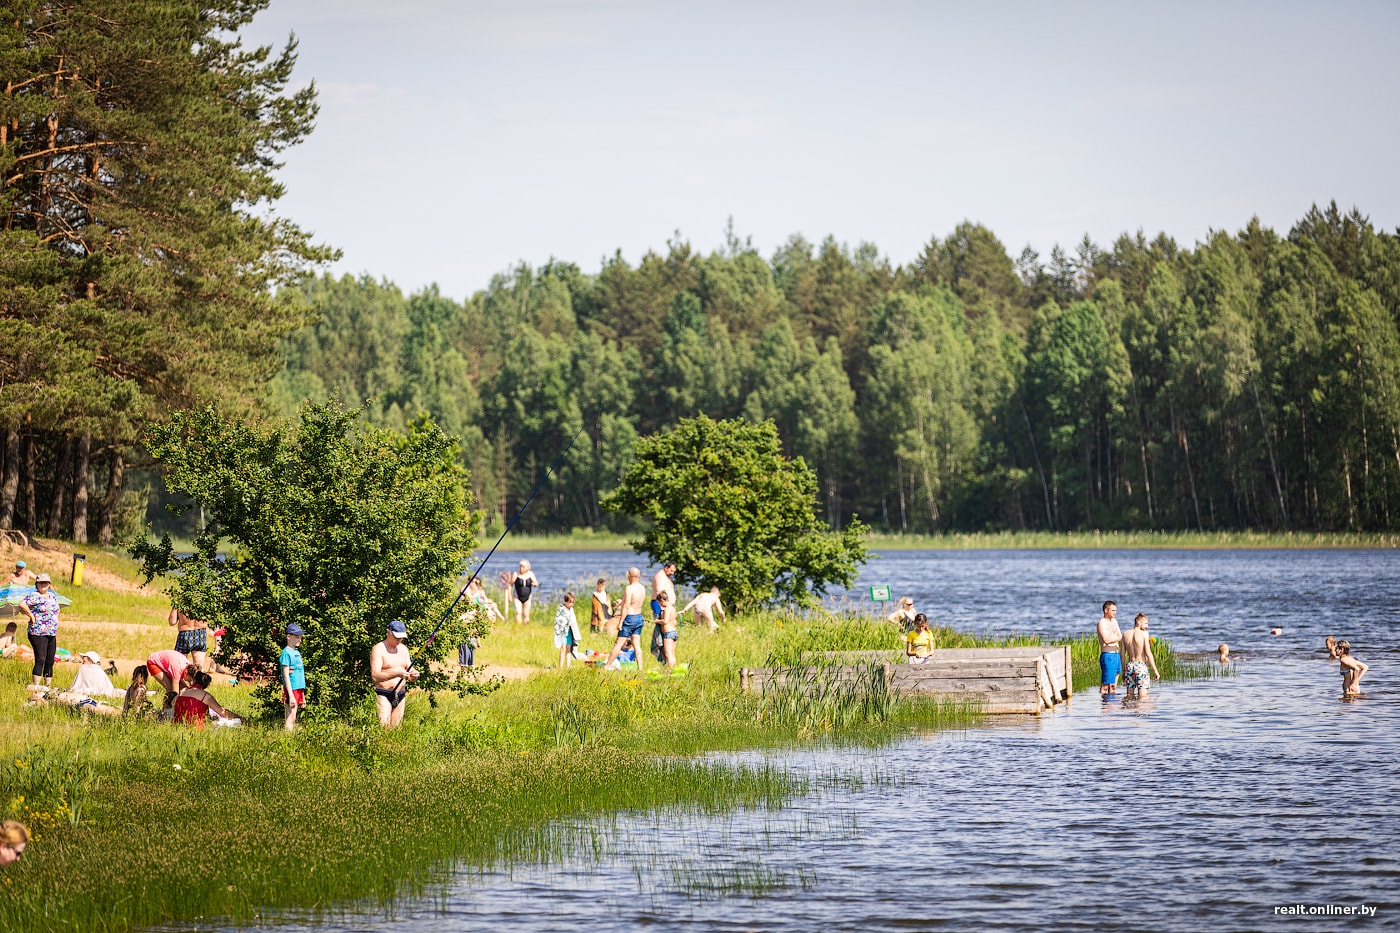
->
[224,551,1400,933]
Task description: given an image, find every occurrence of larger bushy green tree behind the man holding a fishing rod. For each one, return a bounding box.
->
[132,403,480,712]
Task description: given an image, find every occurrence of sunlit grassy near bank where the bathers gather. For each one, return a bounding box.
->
[0,540,1204,932]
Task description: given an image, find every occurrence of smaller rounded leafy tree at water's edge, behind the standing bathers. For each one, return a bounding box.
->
[603,416,865,608]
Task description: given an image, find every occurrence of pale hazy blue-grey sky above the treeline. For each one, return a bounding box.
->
[245,0,1400,298]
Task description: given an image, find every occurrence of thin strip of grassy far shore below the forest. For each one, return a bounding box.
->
[482,528,1400,552]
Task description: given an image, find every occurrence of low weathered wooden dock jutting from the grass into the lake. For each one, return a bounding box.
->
[739,644,1074,714]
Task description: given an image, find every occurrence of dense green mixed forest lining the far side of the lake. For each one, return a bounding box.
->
[269,205,1400,531]
